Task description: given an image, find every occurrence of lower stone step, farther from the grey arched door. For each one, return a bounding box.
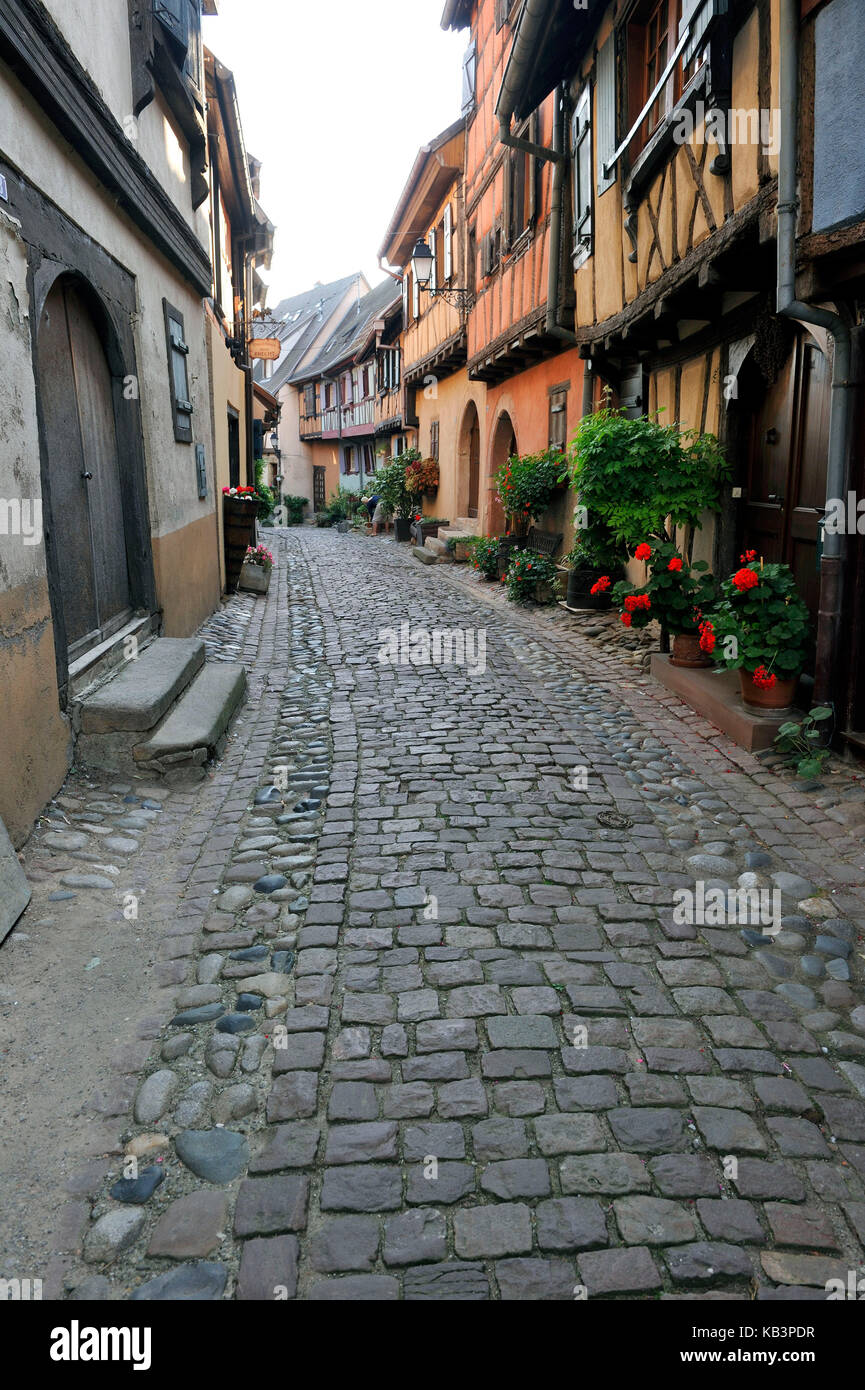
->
[132,662,246,770]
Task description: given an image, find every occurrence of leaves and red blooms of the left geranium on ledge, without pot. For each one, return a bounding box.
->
[612,541,718,635]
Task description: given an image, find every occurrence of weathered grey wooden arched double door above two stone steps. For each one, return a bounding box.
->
[38,275,132,662]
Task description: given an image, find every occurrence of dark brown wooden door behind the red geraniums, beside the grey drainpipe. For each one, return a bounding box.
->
[743,335,832,619]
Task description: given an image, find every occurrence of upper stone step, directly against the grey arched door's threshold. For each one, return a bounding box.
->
[76,637,206,734]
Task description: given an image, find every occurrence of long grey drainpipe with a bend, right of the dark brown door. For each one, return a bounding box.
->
[777,0,854,703]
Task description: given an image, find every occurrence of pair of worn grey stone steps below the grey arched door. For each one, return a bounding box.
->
[71,637,246,783]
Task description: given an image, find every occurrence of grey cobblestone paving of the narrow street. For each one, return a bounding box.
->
[42,530,865,1300]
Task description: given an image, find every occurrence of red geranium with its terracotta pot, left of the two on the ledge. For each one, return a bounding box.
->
[613,539,716,667]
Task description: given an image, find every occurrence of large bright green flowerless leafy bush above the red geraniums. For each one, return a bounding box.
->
[570,404,731,549]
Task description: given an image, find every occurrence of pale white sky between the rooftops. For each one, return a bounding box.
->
[204,0,469,307]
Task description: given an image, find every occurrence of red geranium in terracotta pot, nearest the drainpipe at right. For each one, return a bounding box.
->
[711,550,811,710]
